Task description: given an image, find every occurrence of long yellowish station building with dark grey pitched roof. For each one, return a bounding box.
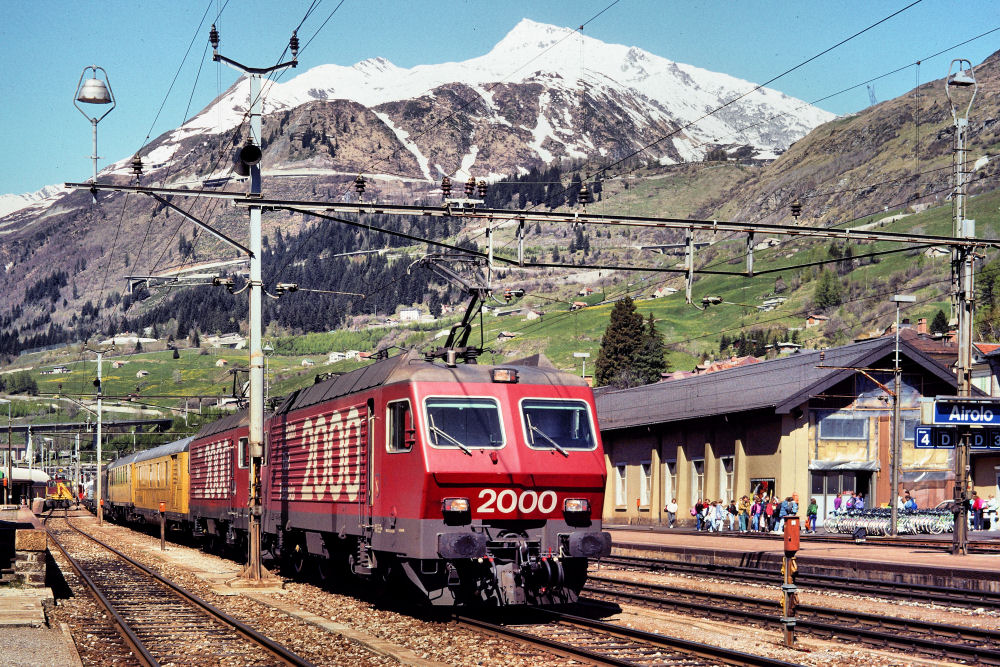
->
[597,336,964,523]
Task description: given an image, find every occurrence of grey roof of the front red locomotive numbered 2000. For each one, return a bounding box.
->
[277,350,587,413]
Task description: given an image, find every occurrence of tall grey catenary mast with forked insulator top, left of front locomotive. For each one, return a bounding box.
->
[208,24,299,582]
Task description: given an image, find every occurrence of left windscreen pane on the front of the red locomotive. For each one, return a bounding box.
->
[424,396,504,454]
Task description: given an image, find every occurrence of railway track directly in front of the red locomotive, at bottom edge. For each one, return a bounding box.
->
[456,609,797,667]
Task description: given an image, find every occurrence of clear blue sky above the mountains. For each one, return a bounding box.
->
[0,0,1000,194]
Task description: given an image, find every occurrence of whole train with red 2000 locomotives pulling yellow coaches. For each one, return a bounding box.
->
[105,352,611,605]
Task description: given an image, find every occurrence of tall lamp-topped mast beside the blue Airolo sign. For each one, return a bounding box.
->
[945,59,978,556]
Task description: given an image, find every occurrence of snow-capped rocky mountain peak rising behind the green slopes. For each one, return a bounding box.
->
[131,19,833,185]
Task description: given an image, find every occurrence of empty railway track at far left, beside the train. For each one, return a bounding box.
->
[46,516,312,666]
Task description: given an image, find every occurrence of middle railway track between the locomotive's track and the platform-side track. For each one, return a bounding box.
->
[584,576,1000,665]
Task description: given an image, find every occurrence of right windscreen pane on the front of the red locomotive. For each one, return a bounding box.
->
[521,398,597,454]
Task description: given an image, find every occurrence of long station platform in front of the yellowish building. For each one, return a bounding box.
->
[605,525,1000,591]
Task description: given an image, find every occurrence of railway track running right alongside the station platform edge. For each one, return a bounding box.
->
[601,556,1000,609]
